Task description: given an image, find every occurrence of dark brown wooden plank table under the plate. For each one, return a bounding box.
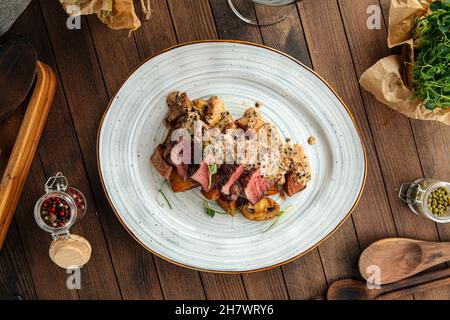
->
[0,0,450,299]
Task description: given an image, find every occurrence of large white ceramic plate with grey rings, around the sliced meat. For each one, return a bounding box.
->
[98,41,366,272]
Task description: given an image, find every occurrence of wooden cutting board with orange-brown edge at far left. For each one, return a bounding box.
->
[0,61,56,249]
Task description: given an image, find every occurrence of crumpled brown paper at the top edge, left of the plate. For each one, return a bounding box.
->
[59,0,150,32]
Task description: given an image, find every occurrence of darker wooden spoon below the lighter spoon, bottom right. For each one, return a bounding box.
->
[327,268,450,300]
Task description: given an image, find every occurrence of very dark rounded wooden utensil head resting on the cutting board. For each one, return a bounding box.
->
[0,38,37,122]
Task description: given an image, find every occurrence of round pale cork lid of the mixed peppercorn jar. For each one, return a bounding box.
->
[49,234,92,269]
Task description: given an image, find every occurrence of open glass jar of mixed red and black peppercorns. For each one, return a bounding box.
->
[34,172,87,239]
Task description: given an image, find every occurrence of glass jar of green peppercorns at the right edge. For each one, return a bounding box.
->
[398,179,450,223]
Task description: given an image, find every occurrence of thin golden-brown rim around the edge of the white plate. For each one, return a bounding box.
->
[96,40,367,274]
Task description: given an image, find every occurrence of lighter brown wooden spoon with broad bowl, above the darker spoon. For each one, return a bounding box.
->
[359,238,450,285]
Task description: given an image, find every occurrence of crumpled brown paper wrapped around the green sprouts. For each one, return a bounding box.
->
[360,0,450,125]
